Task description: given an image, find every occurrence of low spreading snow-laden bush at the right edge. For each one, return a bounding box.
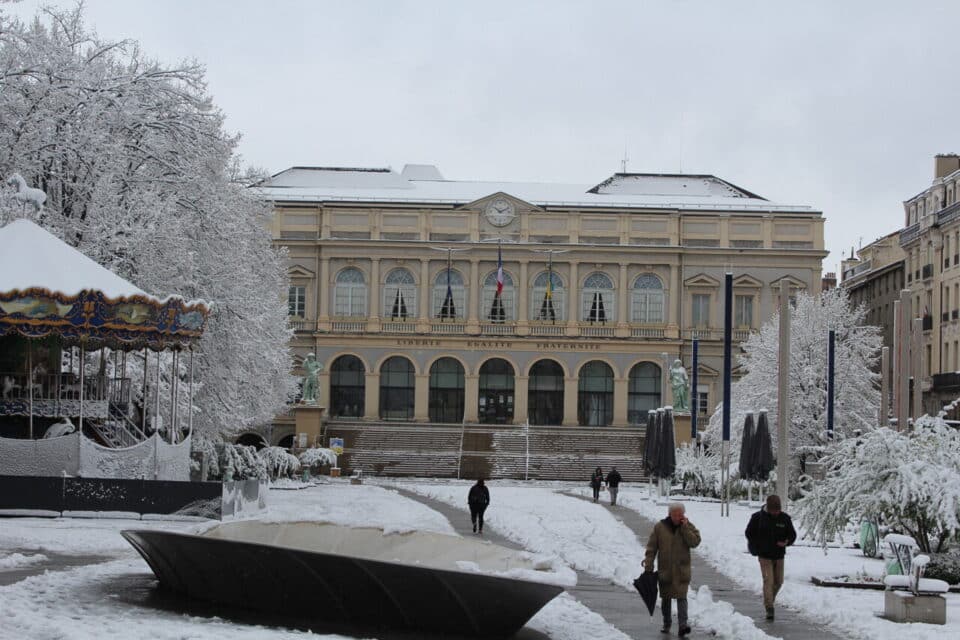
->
[796,417,960,552]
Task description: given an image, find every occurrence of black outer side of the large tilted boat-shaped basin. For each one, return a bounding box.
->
[122,530,563,637]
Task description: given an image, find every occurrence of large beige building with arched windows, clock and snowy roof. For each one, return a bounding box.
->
[255,165,826,440]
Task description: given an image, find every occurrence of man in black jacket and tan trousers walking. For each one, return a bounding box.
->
[744,495,797,620]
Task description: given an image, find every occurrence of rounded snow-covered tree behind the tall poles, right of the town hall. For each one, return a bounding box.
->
[704,289,881,464]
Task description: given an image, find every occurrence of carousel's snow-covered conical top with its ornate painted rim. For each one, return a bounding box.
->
[0,220,210,350]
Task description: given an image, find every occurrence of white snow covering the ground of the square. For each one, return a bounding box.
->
[0,480,960,640]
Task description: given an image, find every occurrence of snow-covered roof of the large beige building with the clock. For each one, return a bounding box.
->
[253,165,819,215]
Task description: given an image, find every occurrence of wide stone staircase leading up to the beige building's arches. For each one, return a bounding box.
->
[325,421,644,483]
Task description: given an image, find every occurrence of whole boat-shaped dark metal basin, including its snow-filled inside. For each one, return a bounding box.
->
[122,521,563,637]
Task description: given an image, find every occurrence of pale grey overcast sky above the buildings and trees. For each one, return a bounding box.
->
[8,0,960,271]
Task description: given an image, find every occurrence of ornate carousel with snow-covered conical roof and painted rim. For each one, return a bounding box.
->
[0,219,209,480]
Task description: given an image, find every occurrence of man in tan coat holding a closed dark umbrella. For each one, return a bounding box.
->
[643,502,700,636]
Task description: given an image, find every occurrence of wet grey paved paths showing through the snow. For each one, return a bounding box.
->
[393,486,840,640]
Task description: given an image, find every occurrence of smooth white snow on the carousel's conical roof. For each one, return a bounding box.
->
[0,219,154,298]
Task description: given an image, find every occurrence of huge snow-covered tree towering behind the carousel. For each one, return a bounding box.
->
[0,6,295,450]
